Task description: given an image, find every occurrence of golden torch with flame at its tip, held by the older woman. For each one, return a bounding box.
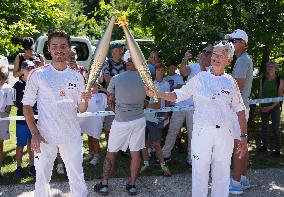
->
[117,19,158,102]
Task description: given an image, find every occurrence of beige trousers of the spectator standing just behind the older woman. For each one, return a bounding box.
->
[162,111,193,163]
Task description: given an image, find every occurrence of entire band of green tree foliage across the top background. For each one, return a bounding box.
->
[0,0,284,72]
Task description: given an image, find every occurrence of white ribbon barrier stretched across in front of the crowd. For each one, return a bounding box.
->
[0,97,284,120]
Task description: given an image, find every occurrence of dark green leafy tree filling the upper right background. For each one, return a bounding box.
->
[129,0,284,66]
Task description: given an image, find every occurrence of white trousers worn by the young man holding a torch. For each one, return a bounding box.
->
[34,143,88,197]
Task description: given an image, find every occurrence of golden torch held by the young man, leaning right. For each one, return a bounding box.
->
[86,16,116,91]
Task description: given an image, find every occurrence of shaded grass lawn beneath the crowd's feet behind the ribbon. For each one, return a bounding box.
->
[2,107,284,184]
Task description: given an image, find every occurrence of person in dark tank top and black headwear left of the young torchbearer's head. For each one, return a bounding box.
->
[13,37,44,77]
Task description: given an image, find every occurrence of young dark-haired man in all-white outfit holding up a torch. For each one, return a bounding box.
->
[22,31,91,197]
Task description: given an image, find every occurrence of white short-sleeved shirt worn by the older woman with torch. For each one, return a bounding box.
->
[174,70,245,128]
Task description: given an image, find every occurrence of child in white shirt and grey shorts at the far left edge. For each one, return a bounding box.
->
[0,65,14,185]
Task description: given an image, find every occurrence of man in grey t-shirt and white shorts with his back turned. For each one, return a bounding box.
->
[94,53,146,195]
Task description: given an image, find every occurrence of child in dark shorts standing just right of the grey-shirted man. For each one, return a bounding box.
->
[140,64,171,176]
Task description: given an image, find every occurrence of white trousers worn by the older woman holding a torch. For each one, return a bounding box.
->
[191,126,234,197]
